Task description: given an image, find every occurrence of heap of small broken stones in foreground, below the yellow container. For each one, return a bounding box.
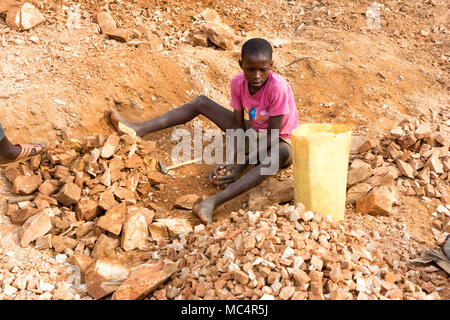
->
[146,204,439,300]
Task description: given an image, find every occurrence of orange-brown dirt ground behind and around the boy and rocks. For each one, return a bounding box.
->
[0,0,450,299]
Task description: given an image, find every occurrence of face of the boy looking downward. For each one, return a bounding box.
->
[239,54,272,92]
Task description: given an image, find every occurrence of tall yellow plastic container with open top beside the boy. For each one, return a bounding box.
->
[292,123,351,222]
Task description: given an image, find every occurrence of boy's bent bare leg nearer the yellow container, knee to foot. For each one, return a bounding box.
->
[192,141,292,224]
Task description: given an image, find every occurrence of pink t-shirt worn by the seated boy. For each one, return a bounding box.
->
[230,71,298,138]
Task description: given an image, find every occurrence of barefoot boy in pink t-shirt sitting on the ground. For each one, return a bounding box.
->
[111,38,298,224]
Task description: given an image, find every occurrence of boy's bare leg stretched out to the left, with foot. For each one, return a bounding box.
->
[111,96,234,137]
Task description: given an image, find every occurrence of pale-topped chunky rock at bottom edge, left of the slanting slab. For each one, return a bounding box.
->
[84,258,130,299]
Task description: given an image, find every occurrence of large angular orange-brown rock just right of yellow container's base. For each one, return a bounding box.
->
[356,190,393,216]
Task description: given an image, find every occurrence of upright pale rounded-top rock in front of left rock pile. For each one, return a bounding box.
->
[121,211,149,251]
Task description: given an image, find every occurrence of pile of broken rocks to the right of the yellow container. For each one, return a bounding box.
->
[347,119,450,215]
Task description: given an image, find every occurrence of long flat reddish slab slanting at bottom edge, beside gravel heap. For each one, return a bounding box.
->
[113,260,178,300]
